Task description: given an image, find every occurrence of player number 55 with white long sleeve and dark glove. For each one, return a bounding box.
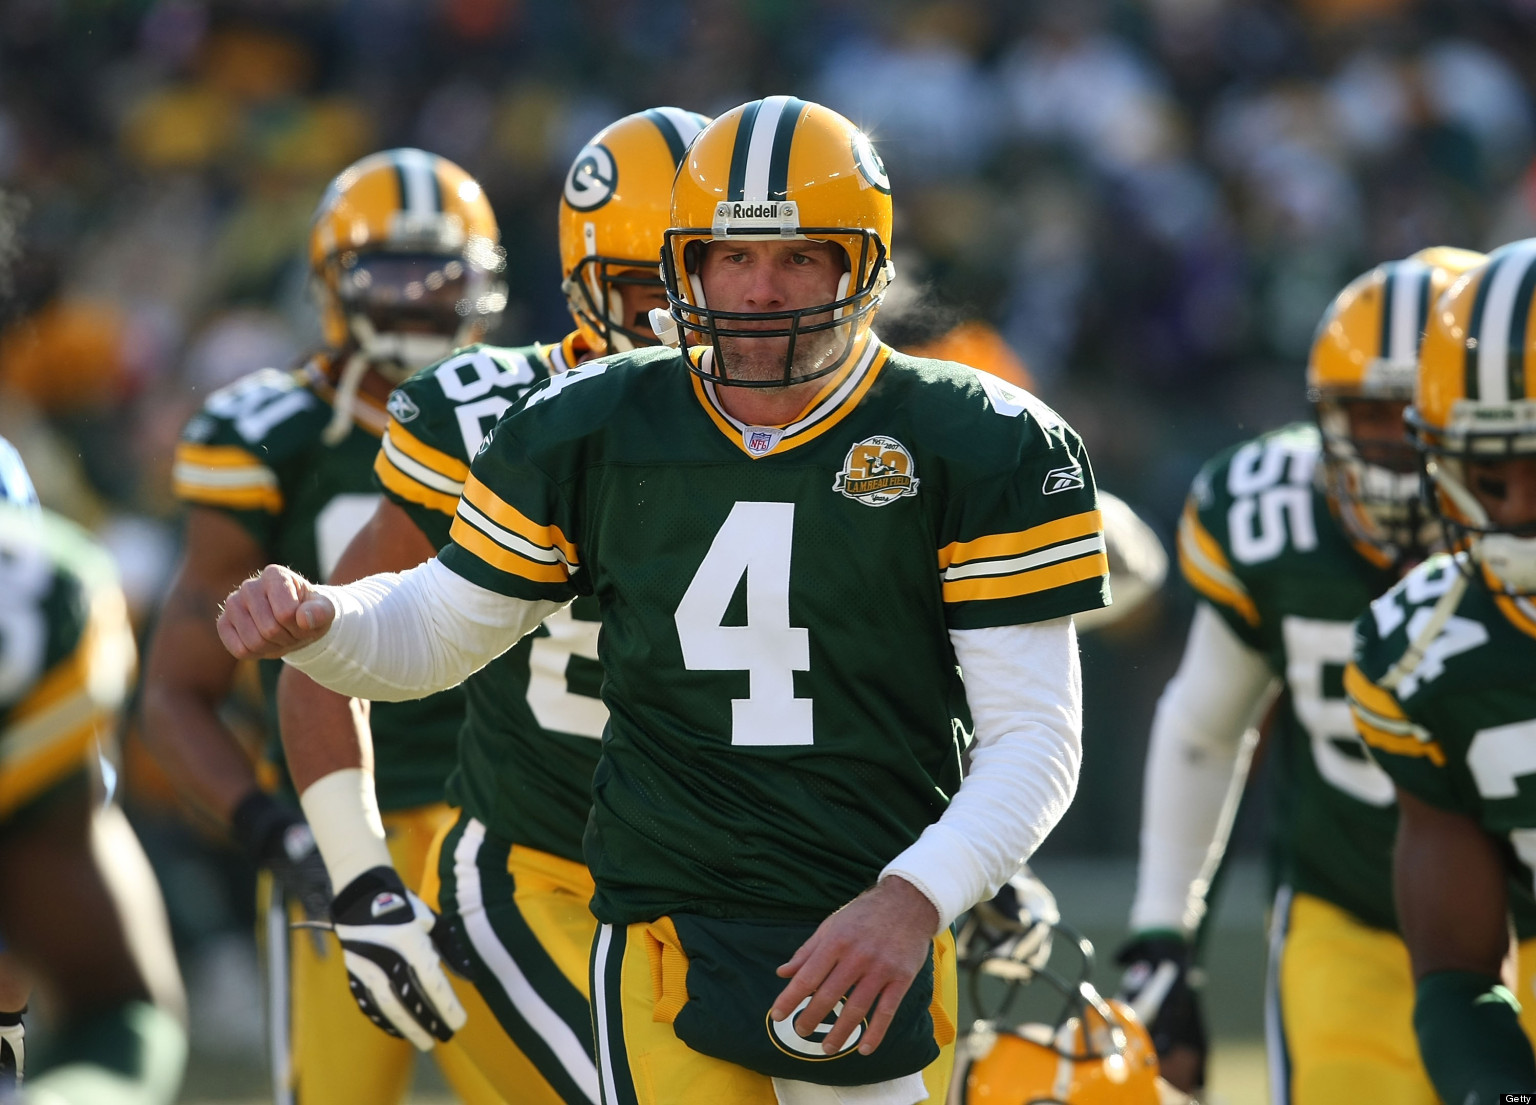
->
[1121,249,1536,1105]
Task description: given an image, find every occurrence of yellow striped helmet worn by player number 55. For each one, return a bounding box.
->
[1307,246,1484,567]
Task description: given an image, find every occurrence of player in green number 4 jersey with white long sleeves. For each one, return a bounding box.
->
[220,95,1107,1105]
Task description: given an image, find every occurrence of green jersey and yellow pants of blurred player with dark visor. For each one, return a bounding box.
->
[175,355,479,1102]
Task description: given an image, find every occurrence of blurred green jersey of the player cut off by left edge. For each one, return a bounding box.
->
[0,506,134,828]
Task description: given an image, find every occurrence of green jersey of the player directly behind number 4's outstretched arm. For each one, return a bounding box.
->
[373,335,608,862]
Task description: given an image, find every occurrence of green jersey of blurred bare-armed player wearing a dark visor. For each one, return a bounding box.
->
[175,357,464,810]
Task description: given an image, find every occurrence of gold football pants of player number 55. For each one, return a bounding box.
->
[1264,887,1536,1105]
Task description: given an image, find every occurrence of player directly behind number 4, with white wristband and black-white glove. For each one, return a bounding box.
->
[280,108,708,1103]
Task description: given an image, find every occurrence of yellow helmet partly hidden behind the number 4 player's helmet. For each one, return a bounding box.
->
[559,108,710,355]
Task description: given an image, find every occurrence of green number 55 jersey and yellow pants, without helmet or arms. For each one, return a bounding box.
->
[1178,423,1536,1105]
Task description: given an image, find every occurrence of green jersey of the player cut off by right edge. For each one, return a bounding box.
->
[1346,553,1536,909]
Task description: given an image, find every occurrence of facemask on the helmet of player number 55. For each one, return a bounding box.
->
[1315,397,1441,570]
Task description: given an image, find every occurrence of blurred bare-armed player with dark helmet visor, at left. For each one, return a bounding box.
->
[143,149,505,1103]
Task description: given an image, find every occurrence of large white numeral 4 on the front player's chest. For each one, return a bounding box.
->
[674,503,814,745]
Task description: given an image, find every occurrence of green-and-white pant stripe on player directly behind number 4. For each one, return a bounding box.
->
[439,818,598,1105]
